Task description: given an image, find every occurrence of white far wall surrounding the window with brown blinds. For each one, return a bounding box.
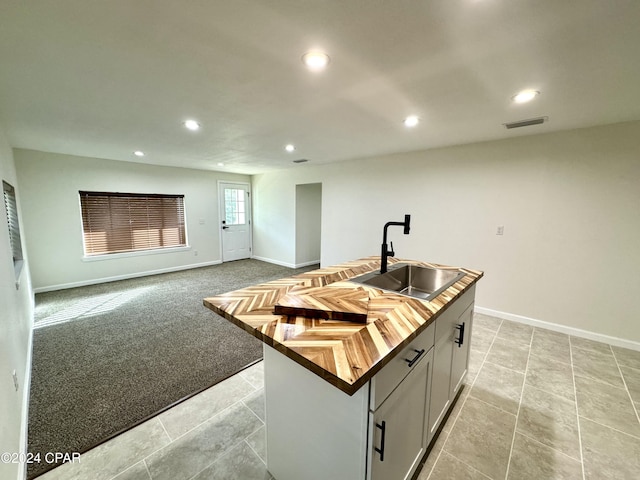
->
[14,149,250,291]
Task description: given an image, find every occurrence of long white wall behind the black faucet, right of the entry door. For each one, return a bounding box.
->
[252,122,640,342]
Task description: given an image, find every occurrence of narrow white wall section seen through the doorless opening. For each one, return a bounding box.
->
[296,183,322,266]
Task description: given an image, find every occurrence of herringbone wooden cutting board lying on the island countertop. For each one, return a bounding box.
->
[273,287,369,323]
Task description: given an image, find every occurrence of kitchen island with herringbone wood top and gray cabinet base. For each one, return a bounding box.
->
[204,257,483,480]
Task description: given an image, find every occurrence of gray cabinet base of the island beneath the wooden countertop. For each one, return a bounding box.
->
[264,288,475,480]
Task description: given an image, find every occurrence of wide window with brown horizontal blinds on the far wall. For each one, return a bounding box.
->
[79,191,187,256]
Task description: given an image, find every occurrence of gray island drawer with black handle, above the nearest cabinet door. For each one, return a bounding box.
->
[369,322,436,411]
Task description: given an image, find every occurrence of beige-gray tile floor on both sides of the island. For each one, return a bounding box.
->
[39,314,640,480]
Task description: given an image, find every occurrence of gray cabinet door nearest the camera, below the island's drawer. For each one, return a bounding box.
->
[369,349,433,480]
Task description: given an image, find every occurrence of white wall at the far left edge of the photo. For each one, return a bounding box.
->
[0,126,33,479]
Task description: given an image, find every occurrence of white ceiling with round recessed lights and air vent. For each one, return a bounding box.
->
[0,0,640,174]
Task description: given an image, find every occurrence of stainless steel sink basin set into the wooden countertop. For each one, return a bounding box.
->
[349,263,465,300]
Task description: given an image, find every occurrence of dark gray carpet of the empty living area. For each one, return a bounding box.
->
[28,260,317,478]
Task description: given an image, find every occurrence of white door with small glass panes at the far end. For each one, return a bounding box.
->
[219,182,251,262]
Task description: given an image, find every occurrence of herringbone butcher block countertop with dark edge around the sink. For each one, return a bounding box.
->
[204,257,483,395]
